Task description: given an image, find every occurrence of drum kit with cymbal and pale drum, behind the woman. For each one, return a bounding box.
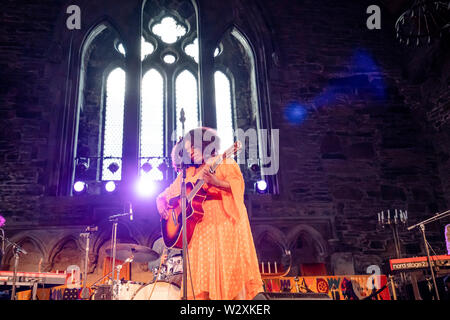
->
[91,243,183,300]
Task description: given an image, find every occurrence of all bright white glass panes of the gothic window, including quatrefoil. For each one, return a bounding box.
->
[98,16,233,185]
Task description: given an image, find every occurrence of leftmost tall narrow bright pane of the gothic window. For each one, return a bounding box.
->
[102,68,125,180]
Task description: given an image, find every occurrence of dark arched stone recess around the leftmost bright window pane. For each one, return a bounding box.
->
[73,17,127,180]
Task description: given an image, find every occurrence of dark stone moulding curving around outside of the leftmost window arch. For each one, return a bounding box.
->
[47,0,145,196]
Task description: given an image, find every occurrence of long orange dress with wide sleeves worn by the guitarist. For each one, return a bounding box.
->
[161,159,263,300]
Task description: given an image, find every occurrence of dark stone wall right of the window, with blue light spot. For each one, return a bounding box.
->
[248,1,448,272]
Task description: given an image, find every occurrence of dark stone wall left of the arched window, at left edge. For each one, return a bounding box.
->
[0,1,64,224]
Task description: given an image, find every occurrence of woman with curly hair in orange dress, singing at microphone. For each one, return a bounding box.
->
[156,127,263,300]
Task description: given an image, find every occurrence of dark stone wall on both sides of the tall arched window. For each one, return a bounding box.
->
[0,0,450,273]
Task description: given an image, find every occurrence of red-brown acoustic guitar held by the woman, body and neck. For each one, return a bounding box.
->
[161,141,242,249]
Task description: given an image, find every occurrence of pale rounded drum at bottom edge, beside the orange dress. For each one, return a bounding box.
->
[131,281,181,300]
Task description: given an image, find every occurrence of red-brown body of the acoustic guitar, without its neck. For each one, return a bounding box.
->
[161,182,206,249]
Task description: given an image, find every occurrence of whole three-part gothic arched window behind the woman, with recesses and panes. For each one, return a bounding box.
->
[72,0,274,195]
